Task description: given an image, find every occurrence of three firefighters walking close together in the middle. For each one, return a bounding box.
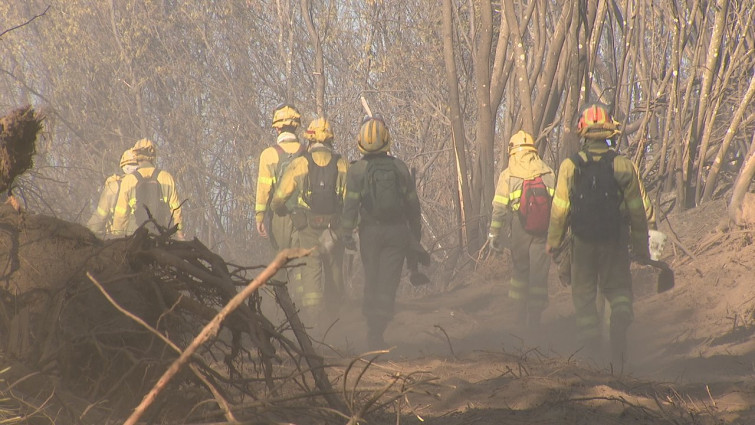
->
[255,104,422,349]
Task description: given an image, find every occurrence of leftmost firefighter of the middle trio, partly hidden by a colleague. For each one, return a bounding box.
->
[254,103,306,284]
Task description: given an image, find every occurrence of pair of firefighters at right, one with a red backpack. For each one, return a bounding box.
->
[488,104,656,365]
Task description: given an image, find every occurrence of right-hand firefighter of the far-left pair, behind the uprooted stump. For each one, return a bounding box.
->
[113,139,184,240]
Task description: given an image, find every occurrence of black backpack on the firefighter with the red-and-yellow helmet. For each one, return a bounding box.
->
[569,150,623,242]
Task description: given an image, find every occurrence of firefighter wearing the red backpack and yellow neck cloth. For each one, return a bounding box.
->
[488,131,556,327]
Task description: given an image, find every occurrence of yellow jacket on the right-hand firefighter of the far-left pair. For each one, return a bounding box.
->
[113,162,183,236]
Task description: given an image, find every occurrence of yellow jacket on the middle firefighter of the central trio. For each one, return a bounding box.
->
[270,143,349,213]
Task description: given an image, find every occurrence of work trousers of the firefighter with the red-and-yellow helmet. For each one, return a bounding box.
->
[571,228,634,344]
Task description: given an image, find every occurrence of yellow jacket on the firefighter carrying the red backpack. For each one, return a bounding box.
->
[489,151,556,237]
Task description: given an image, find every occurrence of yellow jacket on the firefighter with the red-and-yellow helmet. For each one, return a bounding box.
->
[548,139,649,256]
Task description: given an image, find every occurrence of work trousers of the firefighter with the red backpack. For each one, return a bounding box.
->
[509,217,551,320]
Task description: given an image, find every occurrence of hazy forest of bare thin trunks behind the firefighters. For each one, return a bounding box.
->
[0,0,755,276]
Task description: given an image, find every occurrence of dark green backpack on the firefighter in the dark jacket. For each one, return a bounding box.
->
[362,156,406,222]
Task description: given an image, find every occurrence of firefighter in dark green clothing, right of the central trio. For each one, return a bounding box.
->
[341,116,421,349]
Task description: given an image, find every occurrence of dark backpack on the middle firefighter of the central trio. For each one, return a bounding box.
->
[302,152,342,215]
